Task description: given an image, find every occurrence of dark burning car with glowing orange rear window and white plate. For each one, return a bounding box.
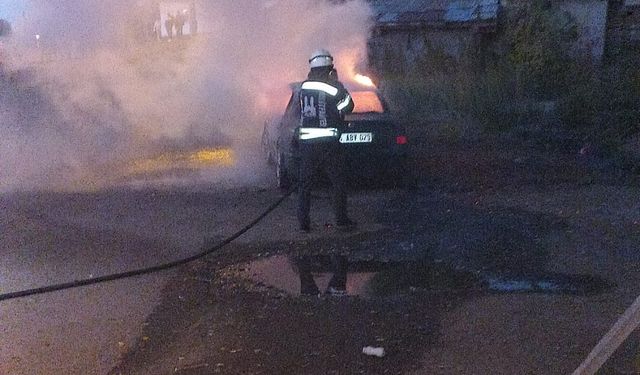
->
[262,76,409,188]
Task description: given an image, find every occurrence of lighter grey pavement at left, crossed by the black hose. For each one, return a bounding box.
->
[0,153,279,375]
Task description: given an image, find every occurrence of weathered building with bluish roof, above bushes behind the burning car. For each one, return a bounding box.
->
[369,0,501,74]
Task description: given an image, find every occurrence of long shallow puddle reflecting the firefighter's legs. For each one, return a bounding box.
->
[236,255,614,298]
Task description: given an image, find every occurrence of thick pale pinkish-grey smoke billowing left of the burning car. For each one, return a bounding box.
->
[0,0,370,191]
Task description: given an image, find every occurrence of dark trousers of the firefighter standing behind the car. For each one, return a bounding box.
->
[298,142,349,226]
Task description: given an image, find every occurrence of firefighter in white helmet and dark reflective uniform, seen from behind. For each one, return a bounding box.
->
[295,49,355,232]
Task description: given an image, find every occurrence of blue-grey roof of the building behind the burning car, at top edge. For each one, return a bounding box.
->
[369,0,500,26]
